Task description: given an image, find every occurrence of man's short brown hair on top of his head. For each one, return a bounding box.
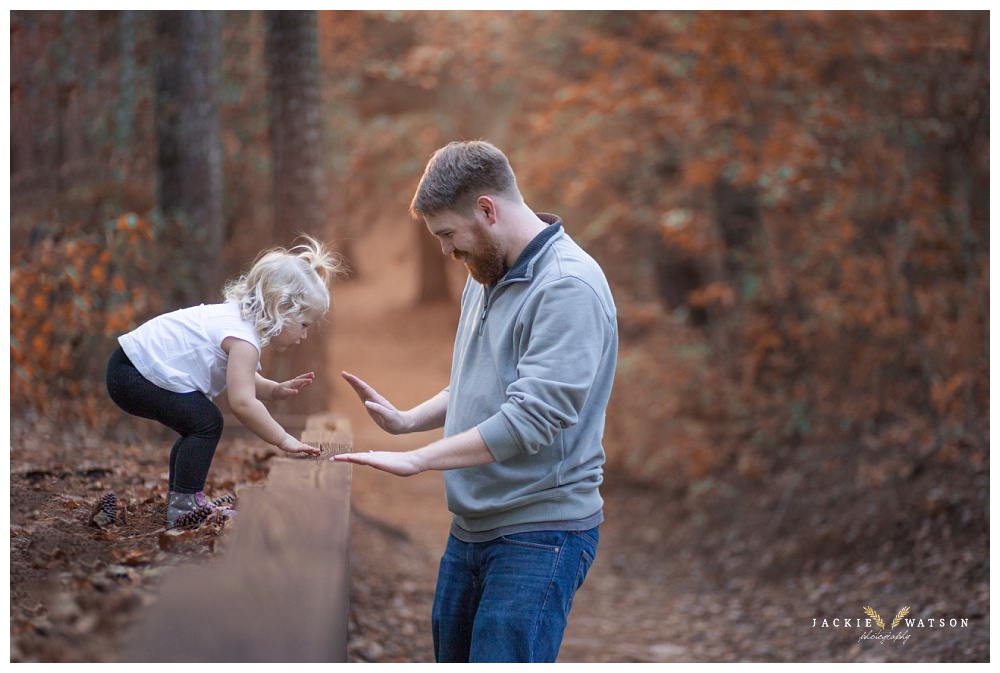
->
[410,140,519,219]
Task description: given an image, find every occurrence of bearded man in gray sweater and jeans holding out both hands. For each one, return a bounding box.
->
[333,141,618,662]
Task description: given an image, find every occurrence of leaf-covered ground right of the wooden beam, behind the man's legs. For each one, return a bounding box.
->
[340,452,990,662]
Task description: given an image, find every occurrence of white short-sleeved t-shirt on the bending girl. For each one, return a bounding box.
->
[118,302,260,398]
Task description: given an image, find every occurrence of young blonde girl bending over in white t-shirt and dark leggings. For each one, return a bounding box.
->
[107,237,341,526]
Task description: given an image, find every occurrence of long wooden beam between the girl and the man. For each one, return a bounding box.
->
[122,414,352,662]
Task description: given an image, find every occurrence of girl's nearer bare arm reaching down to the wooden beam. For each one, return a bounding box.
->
[222,337,320,454]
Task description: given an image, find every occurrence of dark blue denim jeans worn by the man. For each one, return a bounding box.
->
[431,528,599,662]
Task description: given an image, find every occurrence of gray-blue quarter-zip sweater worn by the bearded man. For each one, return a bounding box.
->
[444,213,618,541]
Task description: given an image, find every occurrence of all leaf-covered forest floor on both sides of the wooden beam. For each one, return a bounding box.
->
[10,404,990,662]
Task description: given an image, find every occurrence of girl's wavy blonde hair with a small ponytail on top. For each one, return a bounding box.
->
[224,235,344,346]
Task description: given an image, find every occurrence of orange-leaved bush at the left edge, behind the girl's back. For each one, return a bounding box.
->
[10,213,169,412]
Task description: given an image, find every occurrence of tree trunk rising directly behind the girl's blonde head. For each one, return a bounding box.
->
[265,11,332,414]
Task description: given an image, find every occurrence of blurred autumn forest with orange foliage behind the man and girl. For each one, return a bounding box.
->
[10,10,990,660]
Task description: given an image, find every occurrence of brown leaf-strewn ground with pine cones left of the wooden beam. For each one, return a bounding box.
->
[10,413,270,662]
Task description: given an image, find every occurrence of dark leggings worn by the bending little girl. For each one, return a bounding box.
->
[107,346,223,493]
